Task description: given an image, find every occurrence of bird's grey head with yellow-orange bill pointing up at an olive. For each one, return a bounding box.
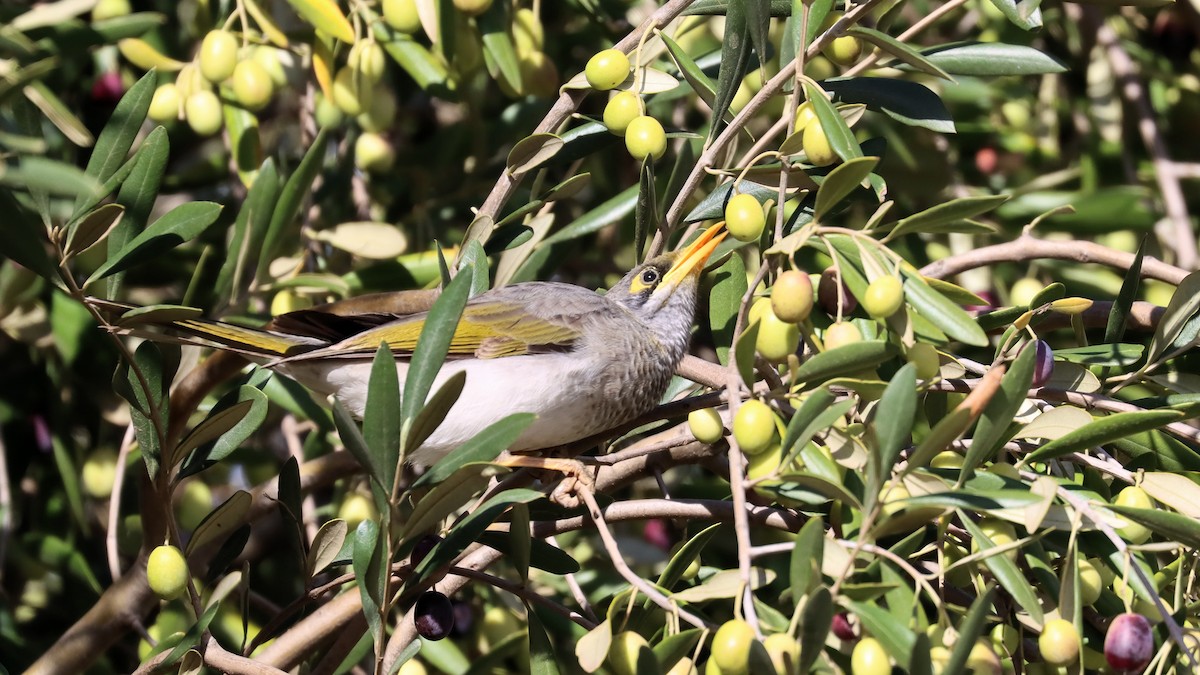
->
[607,225,725,342]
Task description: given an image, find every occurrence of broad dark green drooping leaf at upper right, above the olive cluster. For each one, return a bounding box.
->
[825,77,954,133]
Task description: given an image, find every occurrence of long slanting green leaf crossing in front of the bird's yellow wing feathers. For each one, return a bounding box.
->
[400,268,474,425]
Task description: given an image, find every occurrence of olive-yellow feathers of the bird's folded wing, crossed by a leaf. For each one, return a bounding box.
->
[279,294,580,360]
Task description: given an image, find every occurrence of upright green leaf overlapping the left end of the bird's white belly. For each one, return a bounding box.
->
[362,342,402,504]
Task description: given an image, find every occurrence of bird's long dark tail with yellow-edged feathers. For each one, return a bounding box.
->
[88,298,329,358]
